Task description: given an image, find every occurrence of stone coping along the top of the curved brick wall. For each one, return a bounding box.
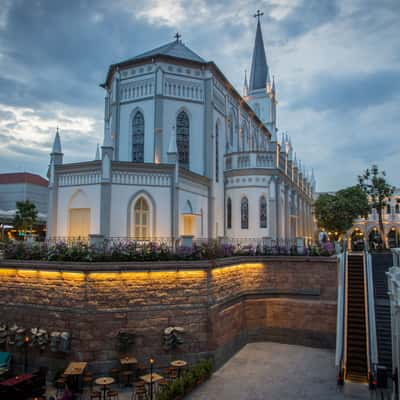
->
[0,256,337,272]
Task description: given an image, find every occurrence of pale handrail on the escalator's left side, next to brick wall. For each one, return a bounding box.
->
[335,250,347,371]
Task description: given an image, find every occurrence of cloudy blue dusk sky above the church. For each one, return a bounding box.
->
[0,0,400,191]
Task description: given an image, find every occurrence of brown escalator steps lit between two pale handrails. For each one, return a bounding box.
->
[346,254,368,382]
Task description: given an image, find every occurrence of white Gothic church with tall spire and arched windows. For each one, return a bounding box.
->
[47,15,315,244]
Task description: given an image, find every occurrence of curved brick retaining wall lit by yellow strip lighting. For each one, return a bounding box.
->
[0,257,337,370]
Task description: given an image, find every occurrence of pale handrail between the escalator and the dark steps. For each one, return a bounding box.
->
[364,251,378,373]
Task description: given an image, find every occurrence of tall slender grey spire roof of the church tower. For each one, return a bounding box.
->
[250,19,268,90]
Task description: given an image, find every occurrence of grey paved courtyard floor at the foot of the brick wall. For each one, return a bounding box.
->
[185,343,370,400]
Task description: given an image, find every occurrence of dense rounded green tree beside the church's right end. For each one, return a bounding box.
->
[314,186,370,239]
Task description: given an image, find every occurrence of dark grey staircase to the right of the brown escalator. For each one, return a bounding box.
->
[372,253,393,376]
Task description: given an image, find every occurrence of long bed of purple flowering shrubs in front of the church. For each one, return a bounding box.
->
[4,240,335,262]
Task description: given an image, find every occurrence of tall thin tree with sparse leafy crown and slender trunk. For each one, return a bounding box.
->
[358,165,395,247]
